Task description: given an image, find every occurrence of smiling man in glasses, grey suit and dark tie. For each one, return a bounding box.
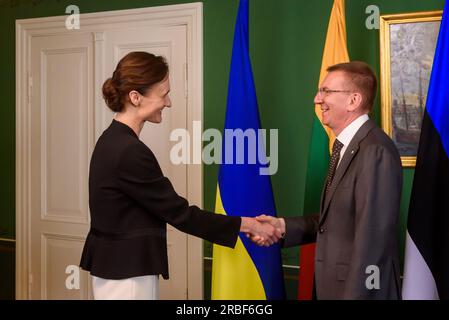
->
[253,62,402,299]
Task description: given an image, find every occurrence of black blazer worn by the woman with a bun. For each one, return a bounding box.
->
[80,120,241,279]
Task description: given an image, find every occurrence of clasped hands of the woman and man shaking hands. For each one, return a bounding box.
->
[240,215,285,247]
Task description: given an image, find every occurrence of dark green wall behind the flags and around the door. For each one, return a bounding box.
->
[0,0,444,299]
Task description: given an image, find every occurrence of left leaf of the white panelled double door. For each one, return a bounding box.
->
[29,33,95,299]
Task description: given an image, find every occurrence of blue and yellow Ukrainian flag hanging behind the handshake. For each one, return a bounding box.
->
[212,0,285,300]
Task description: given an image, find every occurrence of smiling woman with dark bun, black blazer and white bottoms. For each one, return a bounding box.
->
[80,52,280,299]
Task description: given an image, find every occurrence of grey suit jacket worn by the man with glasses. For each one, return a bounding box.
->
[283,120,402,299]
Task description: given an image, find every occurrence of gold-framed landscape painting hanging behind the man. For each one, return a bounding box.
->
[380,11,443,167]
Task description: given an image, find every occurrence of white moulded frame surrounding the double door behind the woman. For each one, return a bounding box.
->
[16,3,203,299]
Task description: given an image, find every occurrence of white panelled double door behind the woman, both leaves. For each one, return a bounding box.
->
[29,12,192,299]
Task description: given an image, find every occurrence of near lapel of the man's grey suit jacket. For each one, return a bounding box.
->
[320,119,376,225]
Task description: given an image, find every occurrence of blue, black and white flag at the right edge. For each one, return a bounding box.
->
[402,1,449,300]
